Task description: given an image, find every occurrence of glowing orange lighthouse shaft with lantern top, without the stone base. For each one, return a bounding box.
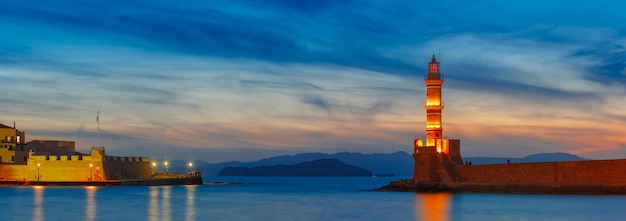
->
[424,55,443,149]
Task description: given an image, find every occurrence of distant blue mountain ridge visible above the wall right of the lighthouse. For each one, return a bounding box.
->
[463,153,589,165]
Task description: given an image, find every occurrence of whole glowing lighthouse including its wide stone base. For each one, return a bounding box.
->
[413,55,463,182]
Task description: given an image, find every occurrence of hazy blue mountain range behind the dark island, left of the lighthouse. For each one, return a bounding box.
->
[197,151,413,176]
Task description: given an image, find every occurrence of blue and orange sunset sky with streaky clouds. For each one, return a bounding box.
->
[0,0,626,162]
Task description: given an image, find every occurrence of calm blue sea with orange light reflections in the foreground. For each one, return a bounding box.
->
[0,177,626,221]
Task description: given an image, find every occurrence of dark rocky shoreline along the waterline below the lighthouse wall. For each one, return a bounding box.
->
[376,179,626,195]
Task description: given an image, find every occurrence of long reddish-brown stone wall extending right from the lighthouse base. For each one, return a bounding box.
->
[456,159,626,183]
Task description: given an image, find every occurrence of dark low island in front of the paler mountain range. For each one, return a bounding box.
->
[218,159,372,176]
